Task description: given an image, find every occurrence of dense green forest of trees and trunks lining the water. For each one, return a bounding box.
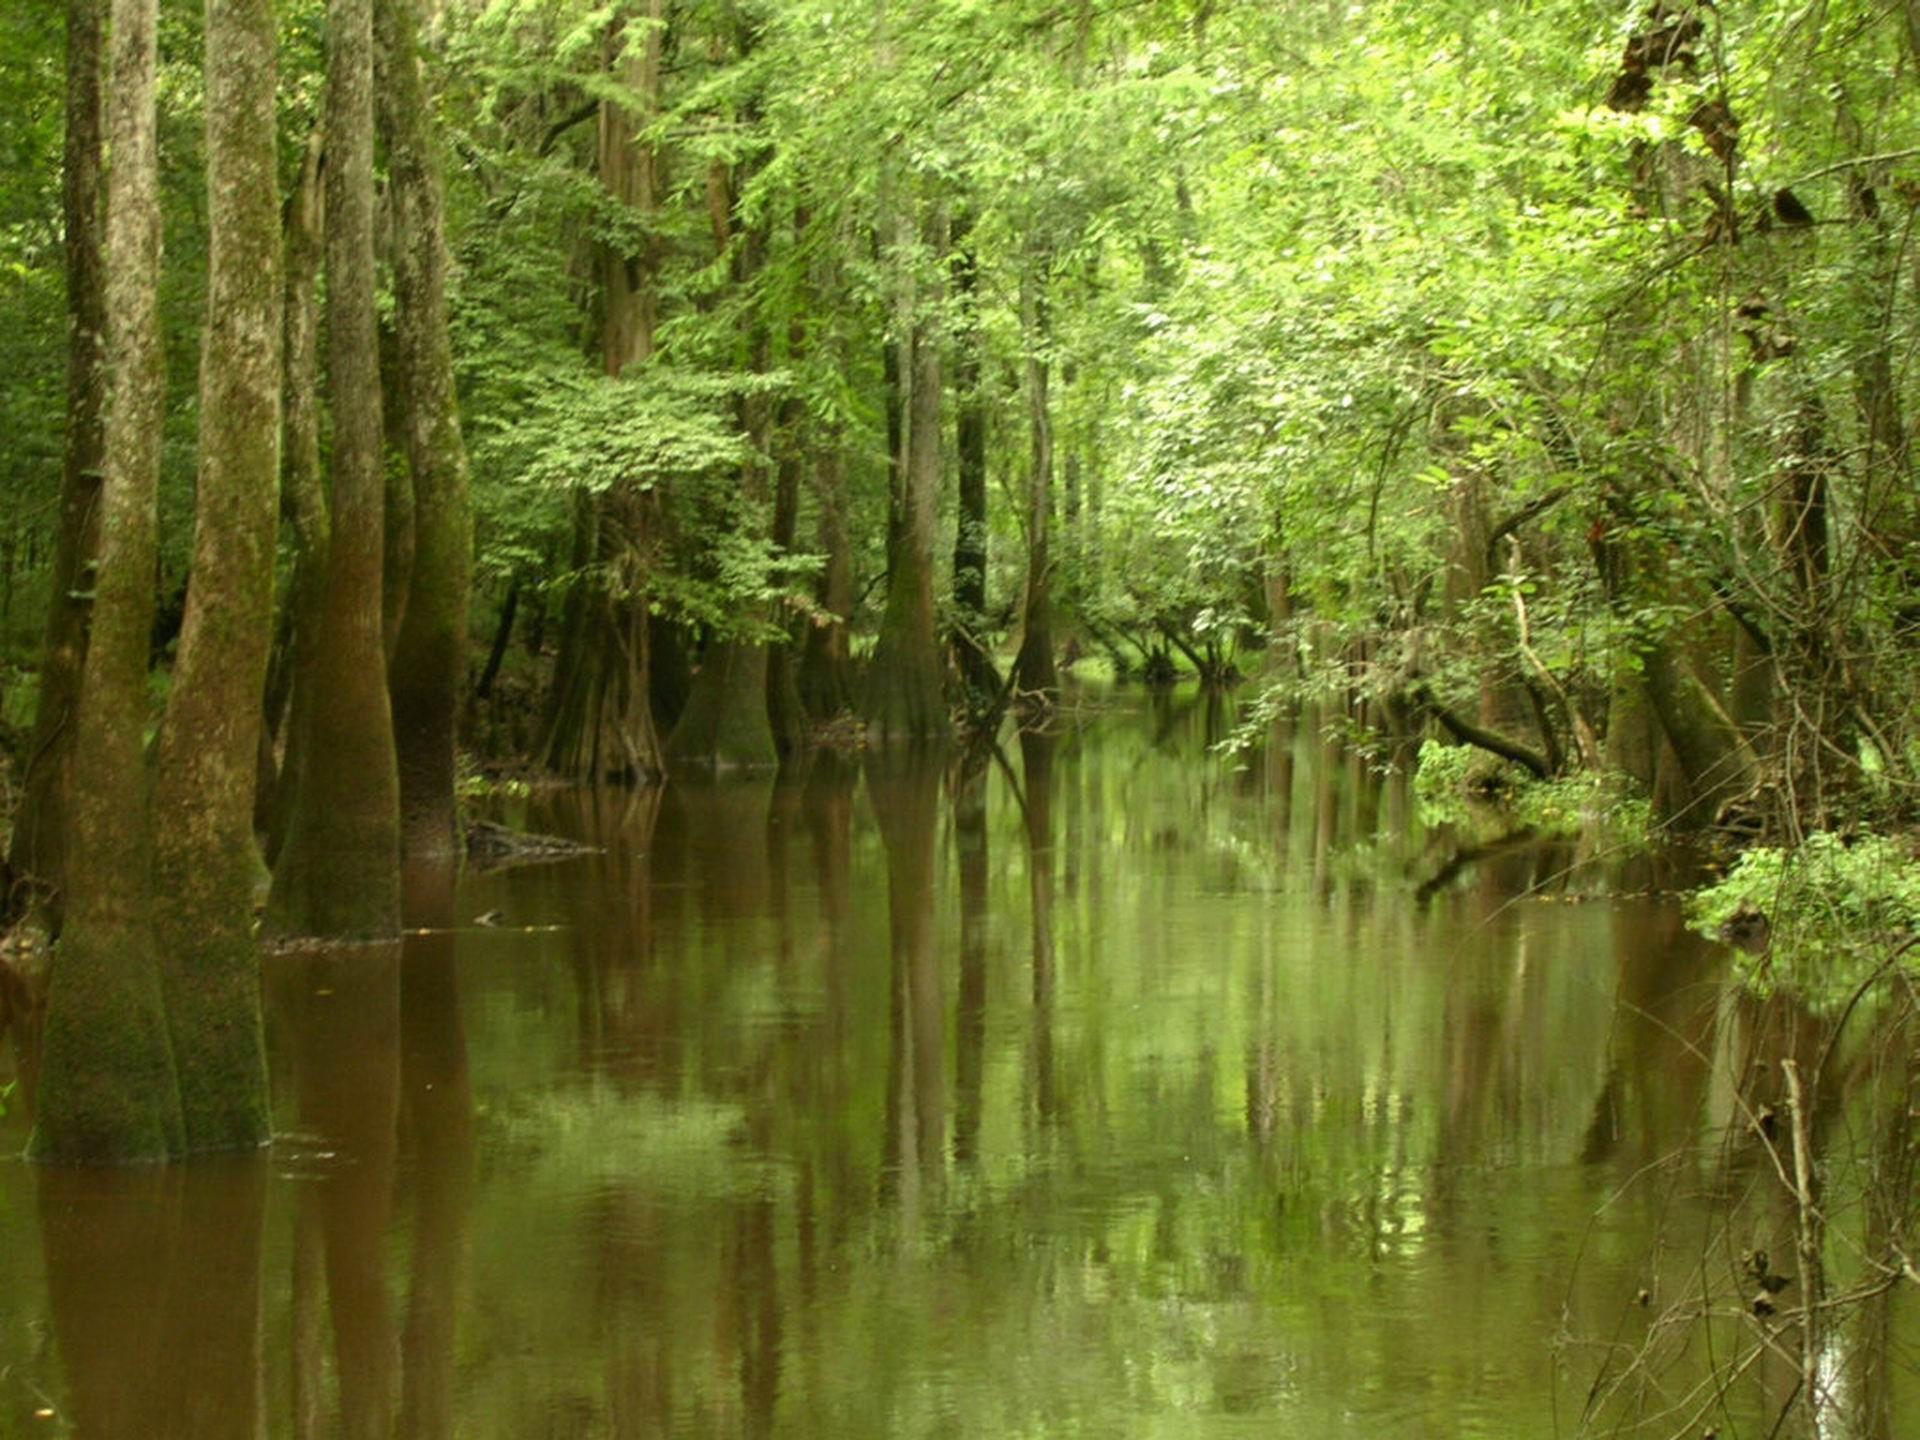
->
[0,0,1920,1182]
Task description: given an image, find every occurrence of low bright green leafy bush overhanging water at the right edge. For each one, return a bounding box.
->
[1686,831,1920,1010]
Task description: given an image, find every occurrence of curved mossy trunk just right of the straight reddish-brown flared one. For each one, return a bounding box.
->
[376,0,472,858]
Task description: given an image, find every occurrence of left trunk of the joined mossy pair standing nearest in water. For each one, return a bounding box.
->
[31,0,185,1164]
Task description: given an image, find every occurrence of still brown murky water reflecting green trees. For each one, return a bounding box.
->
[0,699,1914,1440]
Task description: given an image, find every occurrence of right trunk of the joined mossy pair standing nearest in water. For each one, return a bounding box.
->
[154,0,280,1150]
